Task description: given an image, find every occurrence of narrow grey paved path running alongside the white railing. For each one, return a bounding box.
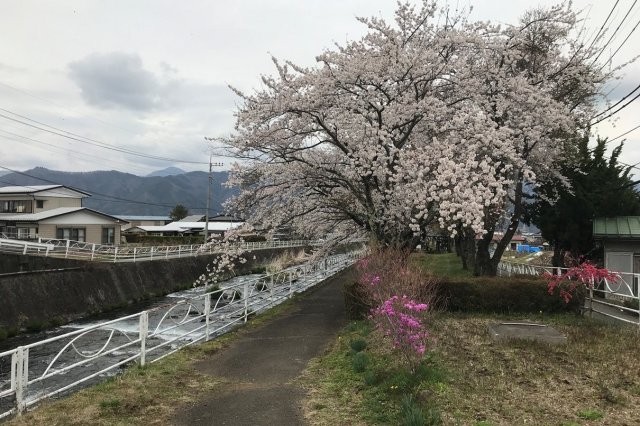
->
[173,270,352,426]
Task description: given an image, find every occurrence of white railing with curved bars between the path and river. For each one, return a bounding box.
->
[0,252,361,419]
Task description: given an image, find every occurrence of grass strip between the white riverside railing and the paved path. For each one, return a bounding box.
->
[6,296,296,426]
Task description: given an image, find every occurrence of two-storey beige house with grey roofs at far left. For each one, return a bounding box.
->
[0,185,124,244]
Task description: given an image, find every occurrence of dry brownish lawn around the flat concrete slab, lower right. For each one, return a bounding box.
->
[433,315,640,425]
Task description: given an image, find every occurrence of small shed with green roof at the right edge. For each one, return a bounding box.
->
[593,216,640,296]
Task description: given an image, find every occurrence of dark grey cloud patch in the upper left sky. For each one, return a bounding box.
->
[69,52,162,111]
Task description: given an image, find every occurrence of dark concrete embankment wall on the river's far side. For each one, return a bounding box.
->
[0,248,300,329]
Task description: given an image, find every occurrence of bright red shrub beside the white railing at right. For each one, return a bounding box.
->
[544,262,620,303]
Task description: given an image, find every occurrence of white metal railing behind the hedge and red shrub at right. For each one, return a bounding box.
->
[498,261,640,327]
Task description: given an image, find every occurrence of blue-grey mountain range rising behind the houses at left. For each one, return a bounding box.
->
[0,167,237,216]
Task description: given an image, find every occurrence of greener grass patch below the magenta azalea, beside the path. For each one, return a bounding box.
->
[301,321,447,425]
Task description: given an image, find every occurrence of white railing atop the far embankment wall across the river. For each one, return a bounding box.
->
[0,239,316,263]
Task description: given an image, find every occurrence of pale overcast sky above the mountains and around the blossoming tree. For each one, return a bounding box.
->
[0,0,640,175]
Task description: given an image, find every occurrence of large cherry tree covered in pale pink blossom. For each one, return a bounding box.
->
[216,1,620,274]
